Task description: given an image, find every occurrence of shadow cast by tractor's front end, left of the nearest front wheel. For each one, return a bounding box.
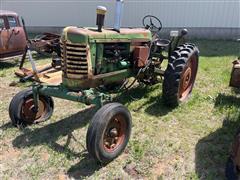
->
[9,108,102,179]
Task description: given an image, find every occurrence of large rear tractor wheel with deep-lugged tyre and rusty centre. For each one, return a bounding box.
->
[163,44,199,107]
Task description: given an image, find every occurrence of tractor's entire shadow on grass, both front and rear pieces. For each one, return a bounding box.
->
[6,86,171,179]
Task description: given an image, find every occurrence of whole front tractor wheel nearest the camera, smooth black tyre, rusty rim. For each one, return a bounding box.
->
[87,103,132,163]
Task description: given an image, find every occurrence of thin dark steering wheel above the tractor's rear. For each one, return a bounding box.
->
[142,15,162,33]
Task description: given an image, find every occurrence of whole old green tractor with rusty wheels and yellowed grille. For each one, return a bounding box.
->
[9,0,199,163]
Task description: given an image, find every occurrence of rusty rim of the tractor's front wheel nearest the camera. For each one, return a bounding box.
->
[103,114,126,153]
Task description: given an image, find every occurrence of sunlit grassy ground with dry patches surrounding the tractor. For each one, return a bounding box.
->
[0,40,240,179]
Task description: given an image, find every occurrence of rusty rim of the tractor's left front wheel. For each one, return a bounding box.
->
[21,98,47,123]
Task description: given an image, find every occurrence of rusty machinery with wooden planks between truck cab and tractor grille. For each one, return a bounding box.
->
[15,19,61,84]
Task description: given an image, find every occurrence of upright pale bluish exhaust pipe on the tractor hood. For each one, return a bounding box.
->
[114,0,124,32]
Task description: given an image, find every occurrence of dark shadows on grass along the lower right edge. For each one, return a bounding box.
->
[195,94,240,179]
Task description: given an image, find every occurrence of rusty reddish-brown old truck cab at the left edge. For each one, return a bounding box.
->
[0,10,27,60]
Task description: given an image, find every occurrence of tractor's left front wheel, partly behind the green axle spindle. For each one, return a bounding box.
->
[9,89,54,127]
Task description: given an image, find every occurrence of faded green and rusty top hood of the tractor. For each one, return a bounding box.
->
[61,26,152,44]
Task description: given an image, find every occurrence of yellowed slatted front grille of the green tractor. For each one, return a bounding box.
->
[60,42,88,79]
